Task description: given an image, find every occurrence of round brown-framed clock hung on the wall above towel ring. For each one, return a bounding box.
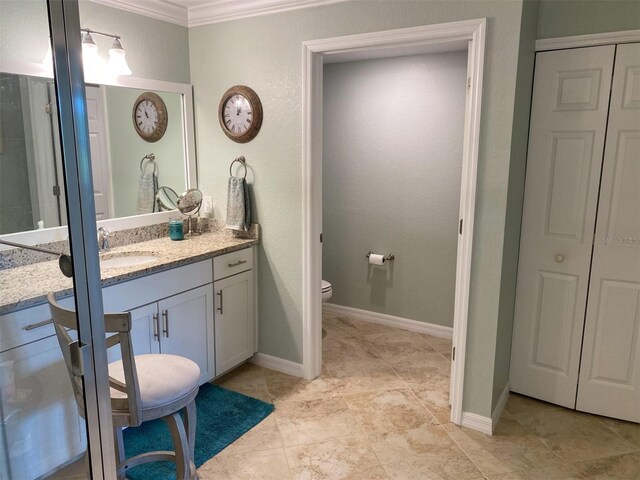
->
[218,85,262,143]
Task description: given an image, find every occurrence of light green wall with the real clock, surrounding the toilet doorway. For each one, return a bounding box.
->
[189,0,522,416]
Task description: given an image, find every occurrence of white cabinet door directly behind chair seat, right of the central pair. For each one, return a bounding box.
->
[158,284,215,383]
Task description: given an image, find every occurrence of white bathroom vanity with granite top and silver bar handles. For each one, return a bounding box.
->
[0,232,258,479]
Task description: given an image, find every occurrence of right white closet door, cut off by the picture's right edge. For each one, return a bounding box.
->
[577,43,640,422]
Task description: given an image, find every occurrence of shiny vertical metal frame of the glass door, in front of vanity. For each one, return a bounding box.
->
[47,0,117,480]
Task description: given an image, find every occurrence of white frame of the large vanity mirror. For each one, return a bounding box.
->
[0,58,198,251]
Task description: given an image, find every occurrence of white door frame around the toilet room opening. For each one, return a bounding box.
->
[302,18,487,424]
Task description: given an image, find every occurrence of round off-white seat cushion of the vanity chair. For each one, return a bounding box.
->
[109,354,200,410]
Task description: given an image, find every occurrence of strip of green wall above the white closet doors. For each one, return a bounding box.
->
[538,0,640,38]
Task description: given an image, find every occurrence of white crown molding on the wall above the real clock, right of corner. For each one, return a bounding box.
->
[188,0,347,27]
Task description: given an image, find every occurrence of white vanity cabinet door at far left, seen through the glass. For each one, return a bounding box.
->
[0,336,86,479]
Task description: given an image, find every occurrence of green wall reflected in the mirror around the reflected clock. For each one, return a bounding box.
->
[103,87,186,217]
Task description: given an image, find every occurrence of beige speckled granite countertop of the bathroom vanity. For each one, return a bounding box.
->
[0,232,259,315]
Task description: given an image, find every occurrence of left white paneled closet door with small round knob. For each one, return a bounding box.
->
[510,46,615,408]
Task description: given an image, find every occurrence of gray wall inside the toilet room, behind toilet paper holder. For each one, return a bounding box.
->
[322,50,467,327]
